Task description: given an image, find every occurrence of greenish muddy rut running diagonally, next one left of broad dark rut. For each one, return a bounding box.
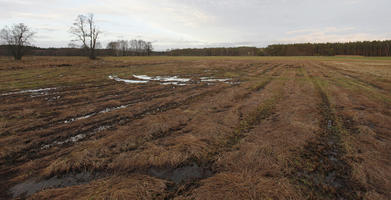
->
[164,65,286,199]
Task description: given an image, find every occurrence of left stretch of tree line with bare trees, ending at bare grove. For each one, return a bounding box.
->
[0,14,153,60]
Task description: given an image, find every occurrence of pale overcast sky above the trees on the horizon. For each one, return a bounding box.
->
[0,0,391,50]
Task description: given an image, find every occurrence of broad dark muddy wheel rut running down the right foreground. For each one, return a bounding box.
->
[292,65,361,199]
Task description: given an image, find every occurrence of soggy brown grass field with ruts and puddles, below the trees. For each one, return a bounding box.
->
[0,57,391,199]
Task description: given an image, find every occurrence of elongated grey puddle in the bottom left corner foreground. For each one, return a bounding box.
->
[10,172,103,198]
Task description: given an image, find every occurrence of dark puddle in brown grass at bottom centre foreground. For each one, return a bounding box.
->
[149,163,213,184]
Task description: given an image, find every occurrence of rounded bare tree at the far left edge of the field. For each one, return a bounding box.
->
[0,23,35,60]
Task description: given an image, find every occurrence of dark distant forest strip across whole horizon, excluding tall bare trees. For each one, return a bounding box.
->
[0,40,391,56]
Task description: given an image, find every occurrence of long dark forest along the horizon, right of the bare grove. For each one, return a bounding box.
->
[167,40,391,56]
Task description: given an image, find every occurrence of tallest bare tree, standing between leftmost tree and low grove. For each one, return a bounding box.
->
[70,14,101,59]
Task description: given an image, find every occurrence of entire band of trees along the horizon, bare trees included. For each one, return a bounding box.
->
[0,14,391,60]
